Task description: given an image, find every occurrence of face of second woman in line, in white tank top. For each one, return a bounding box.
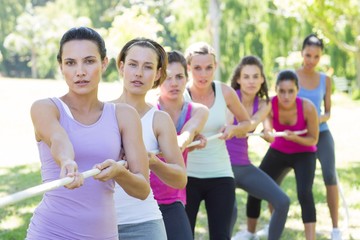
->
[119,45,160,94]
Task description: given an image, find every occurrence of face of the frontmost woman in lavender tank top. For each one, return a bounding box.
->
[60,40,107,94]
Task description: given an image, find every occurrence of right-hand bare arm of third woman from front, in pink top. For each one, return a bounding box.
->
[178,102,209,151]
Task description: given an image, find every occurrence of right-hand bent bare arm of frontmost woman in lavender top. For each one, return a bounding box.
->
[109,103,150,199]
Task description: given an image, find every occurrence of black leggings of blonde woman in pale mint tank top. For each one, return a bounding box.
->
[185,177,235,240]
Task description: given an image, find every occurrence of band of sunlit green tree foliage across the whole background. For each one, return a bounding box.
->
[0,0,360,88]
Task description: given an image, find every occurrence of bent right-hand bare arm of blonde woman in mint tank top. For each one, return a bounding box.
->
[221,84,250,139]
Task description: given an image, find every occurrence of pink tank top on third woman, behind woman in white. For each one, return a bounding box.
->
[150,102,192,205]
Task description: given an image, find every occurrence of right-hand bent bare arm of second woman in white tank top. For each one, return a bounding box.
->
[150,111,187,189]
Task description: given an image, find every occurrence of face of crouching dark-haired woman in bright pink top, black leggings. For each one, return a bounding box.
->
[276,80,298,108]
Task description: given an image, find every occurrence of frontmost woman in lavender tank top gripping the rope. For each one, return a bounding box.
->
[26,27,150,240]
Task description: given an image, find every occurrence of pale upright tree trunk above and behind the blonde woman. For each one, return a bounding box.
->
[209,0,221,81]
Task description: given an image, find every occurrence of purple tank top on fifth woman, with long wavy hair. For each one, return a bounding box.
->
[226,89,259,166]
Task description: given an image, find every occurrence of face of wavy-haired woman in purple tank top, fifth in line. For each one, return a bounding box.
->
[237,65,264,95]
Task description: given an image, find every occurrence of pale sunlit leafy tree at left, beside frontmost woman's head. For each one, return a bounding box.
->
[4,2,91,78]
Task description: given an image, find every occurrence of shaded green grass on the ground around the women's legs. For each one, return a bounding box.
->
[0,160,360,240]
